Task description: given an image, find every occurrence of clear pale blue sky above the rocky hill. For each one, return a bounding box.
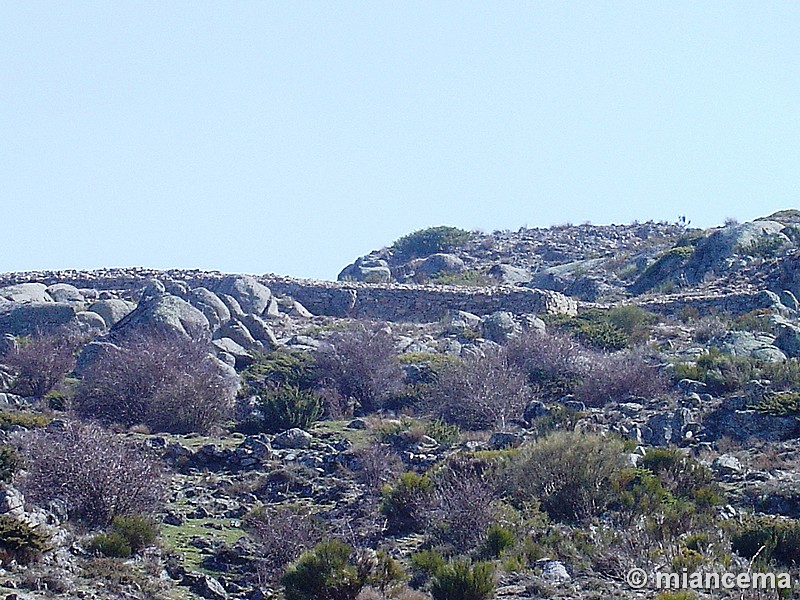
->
[0,0,800,279]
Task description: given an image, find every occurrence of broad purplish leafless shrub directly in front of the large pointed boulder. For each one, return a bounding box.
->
[75,333,238,433]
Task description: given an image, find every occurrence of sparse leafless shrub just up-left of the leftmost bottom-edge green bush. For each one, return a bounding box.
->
[244,506,325,583]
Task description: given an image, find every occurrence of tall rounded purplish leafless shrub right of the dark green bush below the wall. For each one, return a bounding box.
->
[316,324,403,413]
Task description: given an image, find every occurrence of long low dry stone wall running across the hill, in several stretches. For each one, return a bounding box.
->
[0,268,788,322]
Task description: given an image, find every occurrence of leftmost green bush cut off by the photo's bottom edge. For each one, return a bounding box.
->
[281,540,367,600]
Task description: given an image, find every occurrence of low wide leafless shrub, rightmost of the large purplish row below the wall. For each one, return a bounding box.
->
[575,350,667,406]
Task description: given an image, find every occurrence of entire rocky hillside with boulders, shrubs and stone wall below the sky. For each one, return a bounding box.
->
[0,210,800,600]
